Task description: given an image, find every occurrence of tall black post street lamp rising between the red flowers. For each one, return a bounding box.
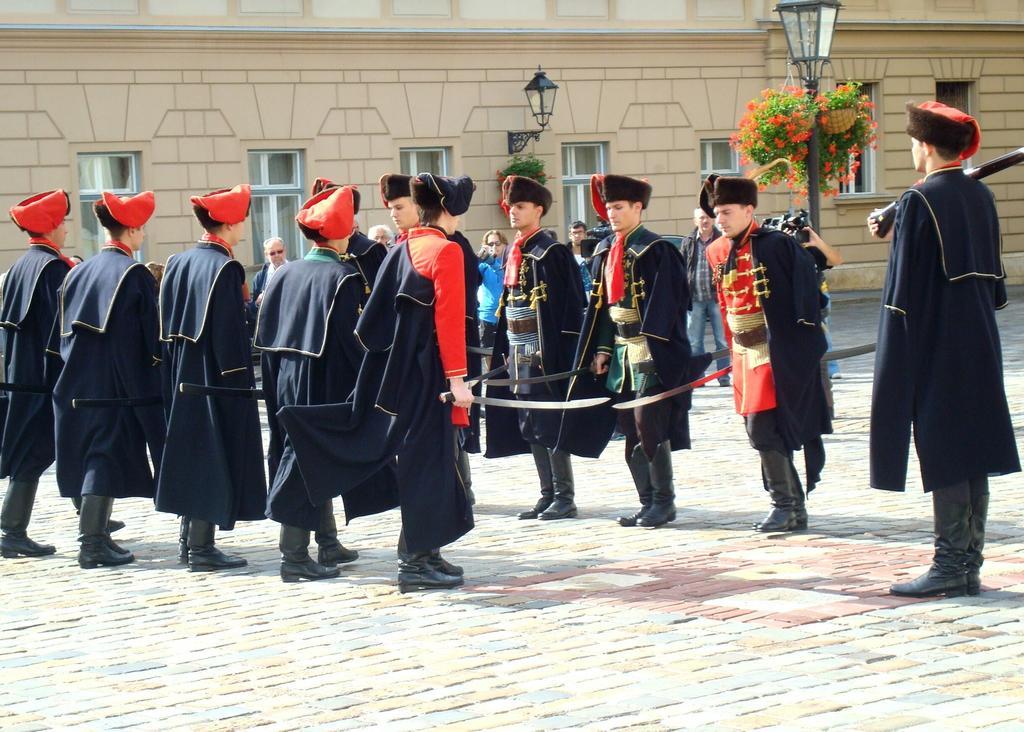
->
[775,0,842,230]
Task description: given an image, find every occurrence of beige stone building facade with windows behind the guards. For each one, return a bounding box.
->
[0,0,1024,288]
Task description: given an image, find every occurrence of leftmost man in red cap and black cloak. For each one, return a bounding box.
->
[0,188,73,558]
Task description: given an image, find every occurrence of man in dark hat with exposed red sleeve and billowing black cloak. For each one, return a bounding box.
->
[278,173,474,592]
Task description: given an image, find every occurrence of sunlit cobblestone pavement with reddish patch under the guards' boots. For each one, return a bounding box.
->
[0,291,1024,730]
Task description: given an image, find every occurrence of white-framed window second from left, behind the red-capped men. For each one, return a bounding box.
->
[249,149,306,262]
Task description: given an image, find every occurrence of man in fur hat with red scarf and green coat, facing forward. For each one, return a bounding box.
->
[562,175,711,528]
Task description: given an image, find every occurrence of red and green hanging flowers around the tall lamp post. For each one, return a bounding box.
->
[730,82,878,200]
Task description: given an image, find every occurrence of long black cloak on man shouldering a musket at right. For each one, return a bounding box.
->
[870,168,1020,490]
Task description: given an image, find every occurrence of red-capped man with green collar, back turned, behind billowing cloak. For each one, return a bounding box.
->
[256,186,397,582]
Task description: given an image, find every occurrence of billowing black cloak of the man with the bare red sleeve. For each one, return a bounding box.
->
[278,243,473,553]
